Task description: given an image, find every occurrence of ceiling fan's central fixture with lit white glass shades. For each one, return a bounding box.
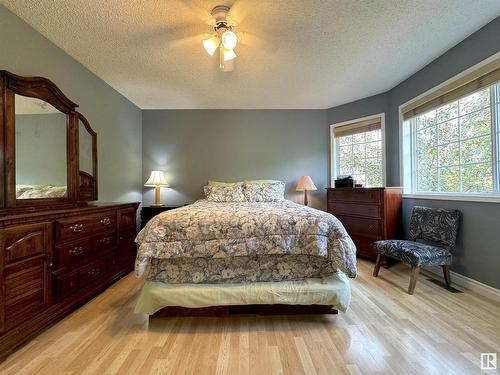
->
[203,5,238,72]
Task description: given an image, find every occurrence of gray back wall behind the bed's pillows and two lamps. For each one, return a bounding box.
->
[142,110,329,209]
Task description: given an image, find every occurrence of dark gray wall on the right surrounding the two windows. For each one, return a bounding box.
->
[327,17,500,288]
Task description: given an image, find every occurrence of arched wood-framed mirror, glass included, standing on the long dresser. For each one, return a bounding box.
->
[0,71,97,211]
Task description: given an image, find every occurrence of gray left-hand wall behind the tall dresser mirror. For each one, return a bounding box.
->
[0,5,142,201]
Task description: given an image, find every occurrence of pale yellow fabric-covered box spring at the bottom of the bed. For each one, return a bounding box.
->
[135,272,351,315]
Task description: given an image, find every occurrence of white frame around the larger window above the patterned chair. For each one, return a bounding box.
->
[398,52,500,203]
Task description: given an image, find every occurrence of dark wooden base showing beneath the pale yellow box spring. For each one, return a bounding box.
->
[150,305,338,318]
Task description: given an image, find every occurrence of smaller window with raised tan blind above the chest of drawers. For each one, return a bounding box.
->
[332,115,384,187]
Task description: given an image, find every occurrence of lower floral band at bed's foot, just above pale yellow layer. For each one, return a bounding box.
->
[147,255,335,284]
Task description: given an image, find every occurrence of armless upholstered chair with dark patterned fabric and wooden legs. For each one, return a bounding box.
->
[373,206,460,294]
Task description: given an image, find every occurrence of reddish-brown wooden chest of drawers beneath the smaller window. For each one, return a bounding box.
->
[327,187,402,259]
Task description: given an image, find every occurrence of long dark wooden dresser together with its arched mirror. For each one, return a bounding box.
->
[0,71,139,360]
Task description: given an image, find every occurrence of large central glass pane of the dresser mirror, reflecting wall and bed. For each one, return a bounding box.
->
[15,94,68,199]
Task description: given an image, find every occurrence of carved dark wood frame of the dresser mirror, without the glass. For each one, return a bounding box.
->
[0,70,97,211]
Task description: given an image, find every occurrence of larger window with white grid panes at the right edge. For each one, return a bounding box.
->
[403,65,500,195]
